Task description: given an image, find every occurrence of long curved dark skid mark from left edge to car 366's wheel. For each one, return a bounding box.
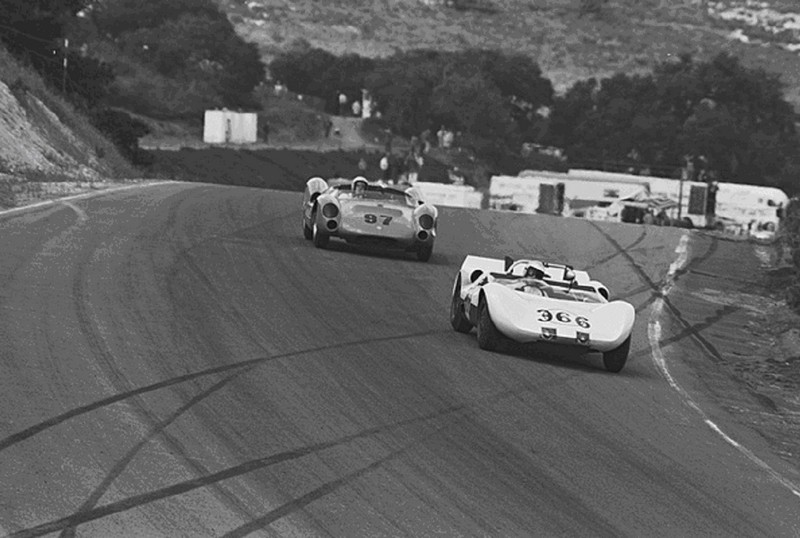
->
[0,329,444,452]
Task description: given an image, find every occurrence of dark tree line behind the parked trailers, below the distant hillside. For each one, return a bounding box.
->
[270,44,800,193]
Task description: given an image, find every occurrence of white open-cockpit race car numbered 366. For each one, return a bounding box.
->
[450,256,636,372]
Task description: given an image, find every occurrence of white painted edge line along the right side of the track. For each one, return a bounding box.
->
[647,229,800,497]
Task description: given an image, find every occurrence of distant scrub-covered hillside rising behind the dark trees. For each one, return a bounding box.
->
[216,0,800,111]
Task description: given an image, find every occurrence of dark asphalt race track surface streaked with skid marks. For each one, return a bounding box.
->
[0,183,800,537]
